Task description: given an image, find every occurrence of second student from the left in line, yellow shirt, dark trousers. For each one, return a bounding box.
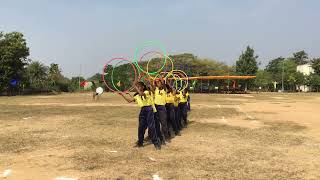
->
[150,77,171,144]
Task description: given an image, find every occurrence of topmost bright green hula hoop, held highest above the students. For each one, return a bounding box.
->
[133,41,167,75]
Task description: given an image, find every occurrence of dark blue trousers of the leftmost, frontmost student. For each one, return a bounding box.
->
[138,106,159,145]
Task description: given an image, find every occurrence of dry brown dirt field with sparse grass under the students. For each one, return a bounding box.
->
[0,93,320,180]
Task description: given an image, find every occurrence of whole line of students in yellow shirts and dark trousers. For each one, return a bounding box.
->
[119,78,190,150]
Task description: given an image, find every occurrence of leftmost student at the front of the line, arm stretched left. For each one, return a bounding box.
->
[119,82,161,150]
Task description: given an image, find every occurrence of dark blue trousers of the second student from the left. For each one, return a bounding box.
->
[155,105,169,141]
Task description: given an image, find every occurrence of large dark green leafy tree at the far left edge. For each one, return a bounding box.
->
[0,32,29,92]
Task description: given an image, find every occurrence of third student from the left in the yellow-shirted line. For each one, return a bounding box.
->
[166,84,181,136]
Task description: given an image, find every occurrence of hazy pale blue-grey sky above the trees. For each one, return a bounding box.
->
[0,0,320,77]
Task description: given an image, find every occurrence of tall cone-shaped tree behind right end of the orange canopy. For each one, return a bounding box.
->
[236,46,258,91]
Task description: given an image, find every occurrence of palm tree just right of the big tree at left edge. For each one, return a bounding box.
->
[27,61,48,89]
